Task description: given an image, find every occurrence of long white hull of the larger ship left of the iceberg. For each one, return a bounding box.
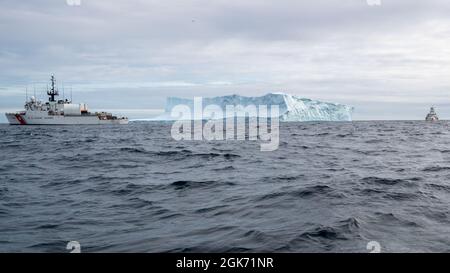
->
[6,113,128,125]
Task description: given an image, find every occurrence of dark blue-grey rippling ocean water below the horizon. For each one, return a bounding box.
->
[0,121,450,252]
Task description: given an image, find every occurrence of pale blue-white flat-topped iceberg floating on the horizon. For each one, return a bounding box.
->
[153,93,353,122]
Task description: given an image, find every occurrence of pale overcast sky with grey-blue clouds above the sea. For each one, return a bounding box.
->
[0,0,450,122]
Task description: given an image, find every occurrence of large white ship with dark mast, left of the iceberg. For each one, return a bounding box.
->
[6,75,128,125]
